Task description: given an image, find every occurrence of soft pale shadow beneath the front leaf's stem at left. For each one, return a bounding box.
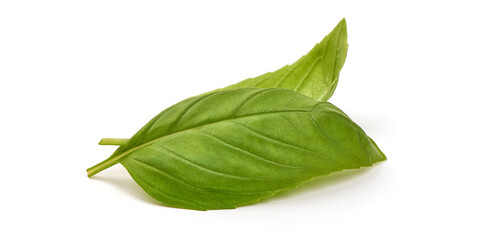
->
[91,169,160,206]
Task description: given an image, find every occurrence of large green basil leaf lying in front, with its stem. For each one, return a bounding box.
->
[88,88,386,210]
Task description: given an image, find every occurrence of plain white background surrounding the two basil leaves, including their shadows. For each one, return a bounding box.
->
[0,0,483,240]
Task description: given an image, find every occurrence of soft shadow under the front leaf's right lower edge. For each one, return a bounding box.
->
[260,161,384,203]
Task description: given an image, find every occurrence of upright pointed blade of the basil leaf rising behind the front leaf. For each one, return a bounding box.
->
[224,19,348,101]
